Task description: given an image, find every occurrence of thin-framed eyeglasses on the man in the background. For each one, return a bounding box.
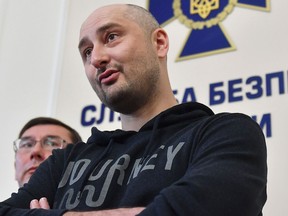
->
[13,136,66,152]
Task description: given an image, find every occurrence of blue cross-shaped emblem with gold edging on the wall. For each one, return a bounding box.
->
[148,0,270,61]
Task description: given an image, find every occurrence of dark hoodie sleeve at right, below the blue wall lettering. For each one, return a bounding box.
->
[139,114,267,216]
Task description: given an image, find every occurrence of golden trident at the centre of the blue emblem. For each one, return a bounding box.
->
[190,0,219,19]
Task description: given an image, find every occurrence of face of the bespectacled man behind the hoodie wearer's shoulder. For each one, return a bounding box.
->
[15,125,72,186]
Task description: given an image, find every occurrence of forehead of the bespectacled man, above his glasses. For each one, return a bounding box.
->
[21,124,70,141]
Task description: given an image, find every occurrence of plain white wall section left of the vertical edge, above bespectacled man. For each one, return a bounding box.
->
[0,0,69,200]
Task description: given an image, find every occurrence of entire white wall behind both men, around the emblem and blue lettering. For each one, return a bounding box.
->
[0,0,288,216]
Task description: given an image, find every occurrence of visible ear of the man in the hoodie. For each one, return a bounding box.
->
[153,28,169,58]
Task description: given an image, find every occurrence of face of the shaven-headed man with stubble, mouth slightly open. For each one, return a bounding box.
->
[79,6,160,114]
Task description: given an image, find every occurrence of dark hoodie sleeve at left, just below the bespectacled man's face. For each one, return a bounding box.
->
[0,150,65,216]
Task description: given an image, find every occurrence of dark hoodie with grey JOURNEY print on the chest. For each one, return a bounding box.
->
[0,103,267,216]
